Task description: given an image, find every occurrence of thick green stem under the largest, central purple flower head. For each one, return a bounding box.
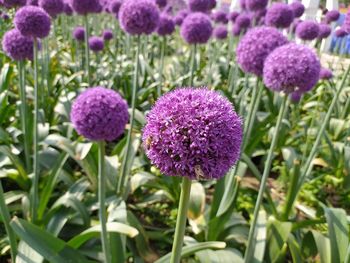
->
[170,177,192,263]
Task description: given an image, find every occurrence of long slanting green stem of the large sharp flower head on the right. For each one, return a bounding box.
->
[244,95,288,263]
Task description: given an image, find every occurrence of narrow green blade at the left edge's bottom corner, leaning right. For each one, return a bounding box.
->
[0,181,17,262]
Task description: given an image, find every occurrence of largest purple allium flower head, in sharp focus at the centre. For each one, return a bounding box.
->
[142,88,242,180]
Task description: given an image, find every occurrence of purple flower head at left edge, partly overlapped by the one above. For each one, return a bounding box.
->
[2,29,34,61]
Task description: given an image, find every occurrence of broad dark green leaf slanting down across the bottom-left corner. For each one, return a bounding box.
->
[10,218,88,263]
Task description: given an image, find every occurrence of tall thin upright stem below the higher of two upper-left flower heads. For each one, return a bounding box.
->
[31,38,40,222]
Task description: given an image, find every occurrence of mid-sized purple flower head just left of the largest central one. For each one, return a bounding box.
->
[71,87,129,141]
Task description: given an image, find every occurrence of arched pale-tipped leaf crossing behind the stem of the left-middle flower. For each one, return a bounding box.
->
[68,222,139,248]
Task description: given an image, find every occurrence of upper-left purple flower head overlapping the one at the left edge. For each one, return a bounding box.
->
[14,6,51,38]
